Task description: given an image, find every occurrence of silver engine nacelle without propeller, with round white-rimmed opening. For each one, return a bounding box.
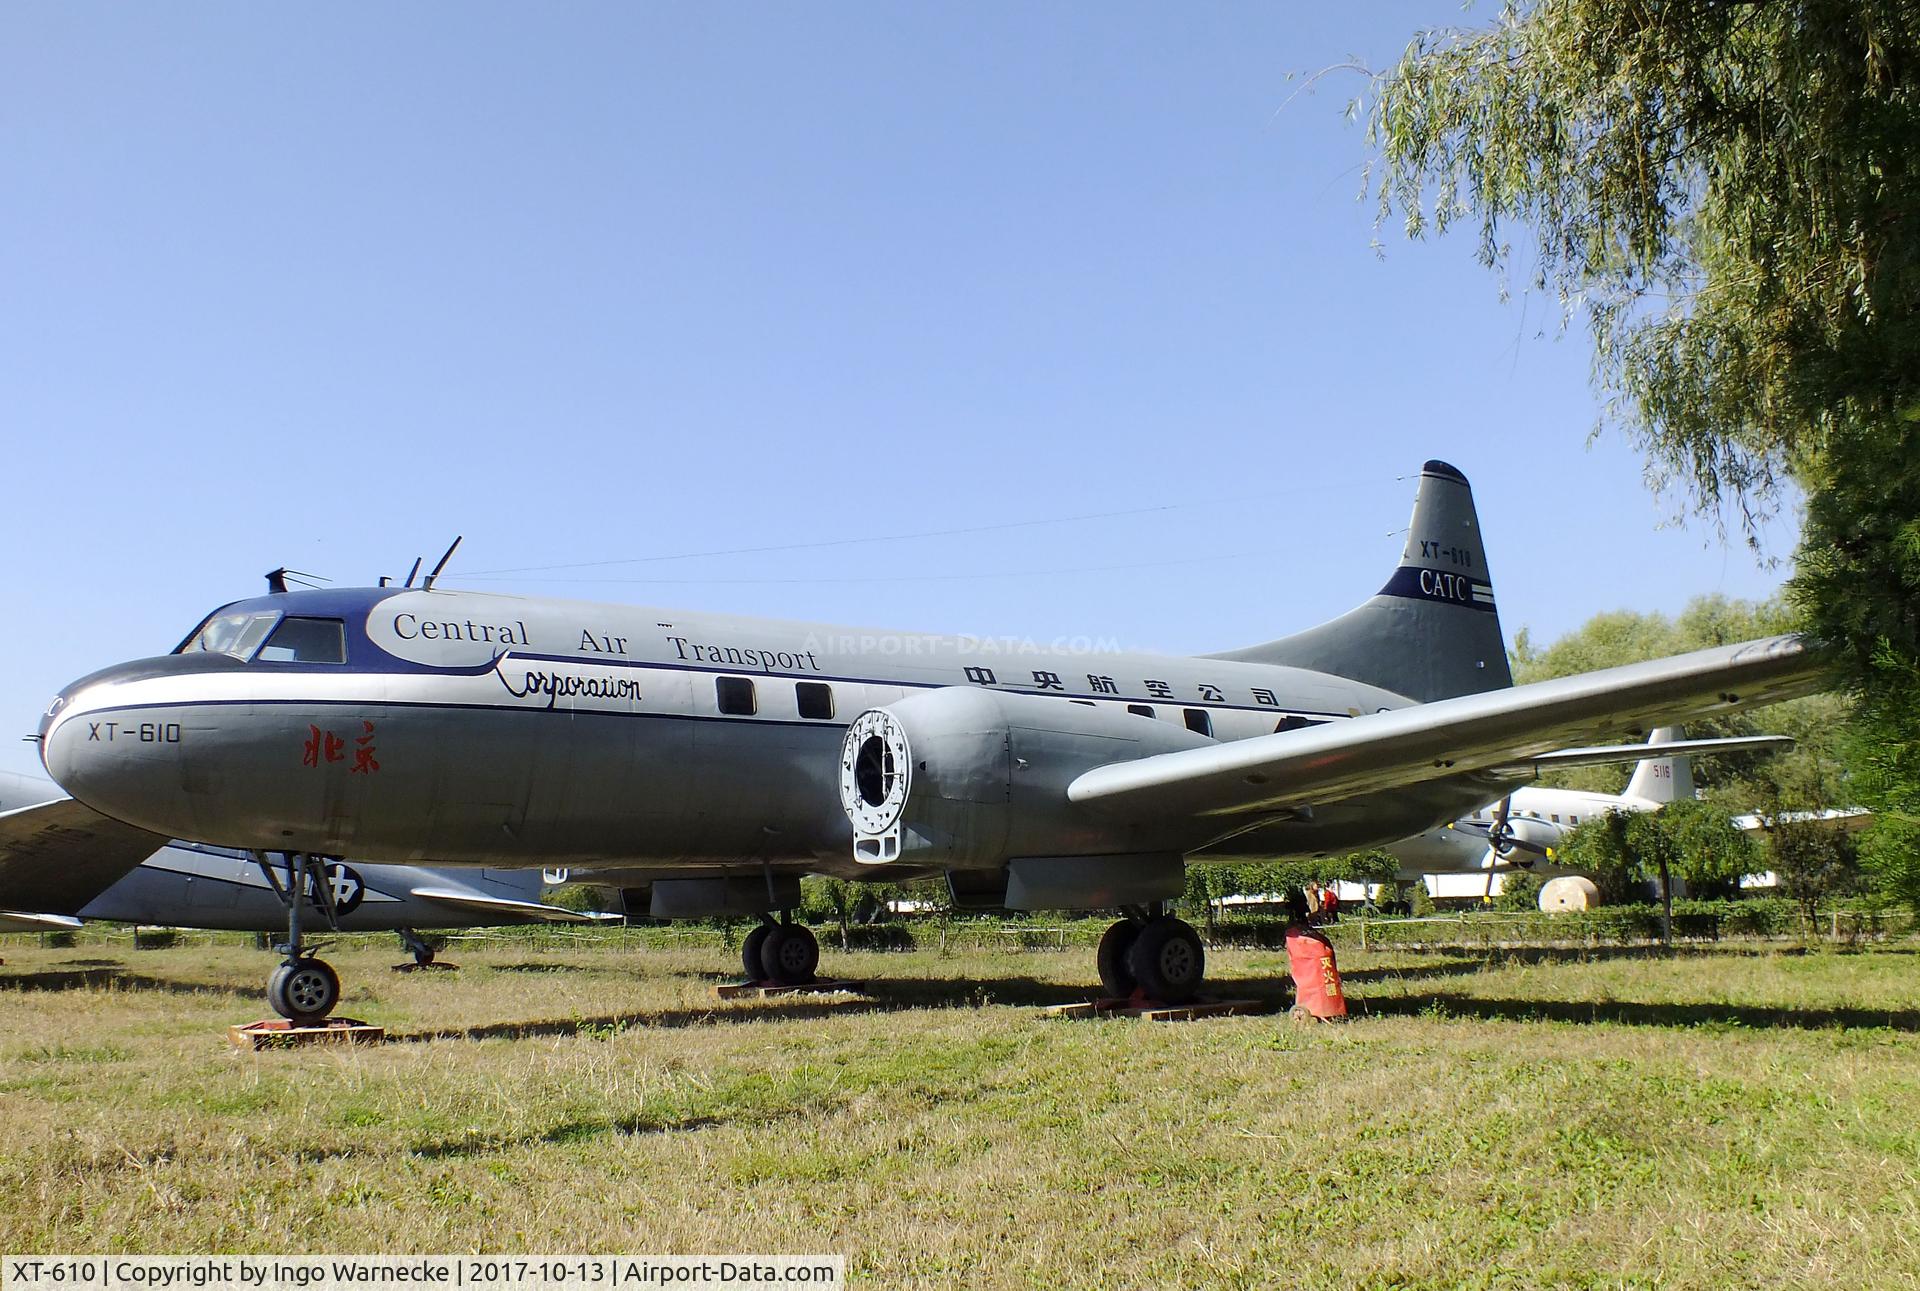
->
[839,686,1213,870]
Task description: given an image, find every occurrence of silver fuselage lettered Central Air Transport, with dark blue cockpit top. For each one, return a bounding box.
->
[40,588,1511,872]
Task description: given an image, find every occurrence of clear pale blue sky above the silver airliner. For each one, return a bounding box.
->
[0,0,1791,770]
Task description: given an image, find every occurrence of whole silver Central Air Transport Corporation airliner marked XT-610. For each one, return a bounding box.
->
[40,461,1820,1003]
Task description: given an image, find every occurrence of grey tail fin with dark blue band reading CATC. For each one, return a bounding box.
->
[1212,461,1513,703]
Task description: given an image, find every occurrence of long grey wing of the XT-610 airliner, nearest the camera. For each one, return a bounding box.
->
[1068,636,1822,824]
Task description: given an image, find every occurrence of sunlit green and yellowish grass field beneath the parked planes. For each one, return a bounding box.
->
[0,939,1920,1287]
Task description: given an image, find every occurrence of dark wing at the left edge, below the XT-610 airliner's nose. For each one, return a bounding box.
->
[0,797,167,914]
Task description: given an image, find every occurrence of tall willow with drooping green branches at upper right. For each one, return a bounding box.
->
[1369,0,1920,856]
